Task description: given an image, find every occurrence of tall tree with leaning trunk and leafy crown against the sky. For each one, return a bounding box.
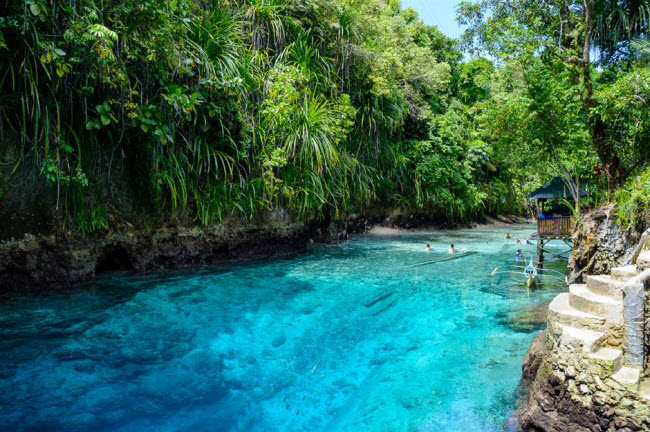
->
[459,0,650,189]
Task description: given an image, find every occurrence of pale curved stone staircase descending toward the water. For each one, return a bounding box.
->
[548,250,650,394]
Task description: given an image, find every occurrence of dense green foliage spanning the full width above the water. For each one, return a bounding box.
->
[0,0,650,232]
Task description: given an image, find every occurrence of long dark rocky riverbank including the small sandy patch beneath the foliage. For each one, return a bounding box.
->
[0,212,528,291]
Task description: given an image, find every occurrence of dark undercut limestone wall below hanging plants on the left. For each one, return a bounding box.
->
[0,223,316,292]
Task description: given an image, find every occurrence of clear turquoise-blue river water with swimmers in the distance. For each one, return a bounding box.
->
[0,227,562,432]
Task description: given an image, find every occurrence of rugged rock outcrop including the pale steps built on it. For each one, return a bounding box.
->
[521,245,650,432]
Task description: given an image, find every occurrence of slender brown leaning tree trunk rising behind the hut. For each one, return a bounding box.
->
[582,0,625,192]
